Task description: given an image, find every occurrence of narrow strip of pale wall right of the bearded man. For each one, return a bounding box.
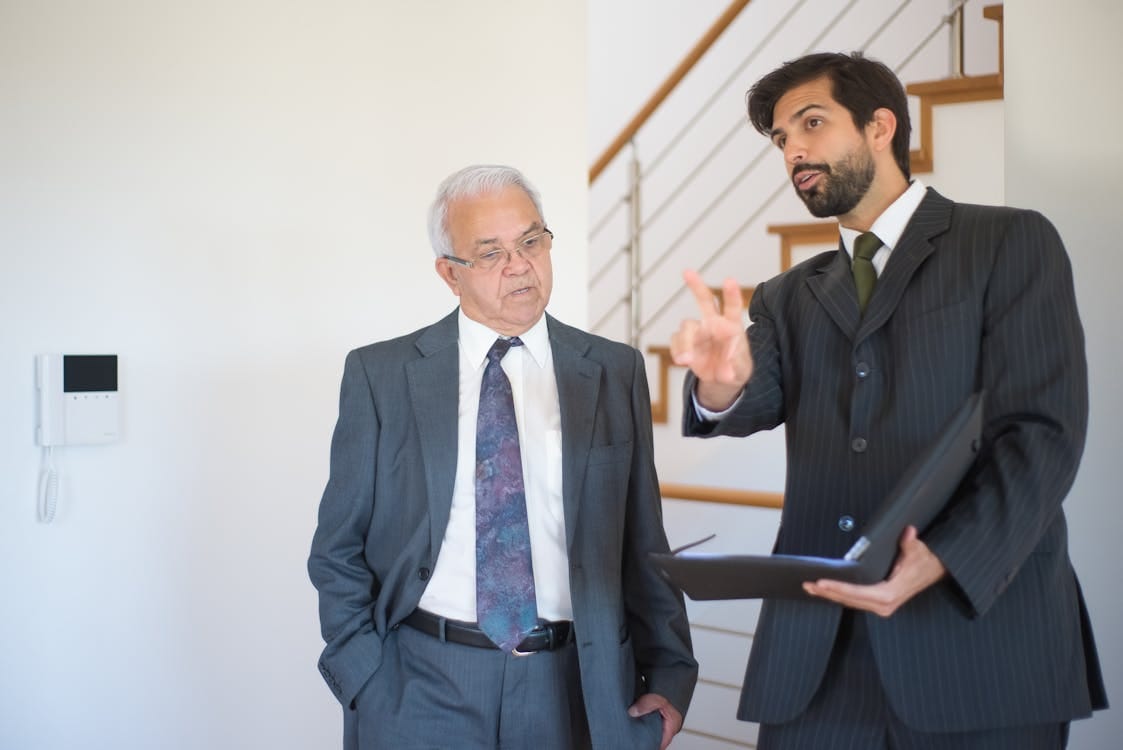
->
[1005,0,1123,750]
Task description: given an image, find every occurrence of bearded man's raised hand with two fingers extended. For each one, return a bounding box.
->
[670,271,752,411]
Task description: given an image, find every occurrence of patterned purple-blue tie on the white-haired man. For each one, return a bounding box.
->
[476,338,538,651]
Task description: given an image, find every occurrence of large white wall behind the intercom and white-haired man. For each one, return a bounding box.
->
[0,0,587,750]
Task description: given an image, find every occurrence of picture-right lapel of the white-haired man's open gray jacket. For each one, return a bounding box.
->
[546,315,602,548]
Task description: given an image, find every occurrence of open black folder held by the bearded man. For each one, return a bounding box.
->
[651,393,983,601]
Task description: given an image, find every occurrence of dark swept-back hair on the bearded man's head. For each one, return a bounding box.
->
[745,52,912,180]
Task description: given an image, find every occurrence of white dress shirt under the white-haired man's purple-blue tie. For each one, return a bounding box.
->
[419,310,573,622]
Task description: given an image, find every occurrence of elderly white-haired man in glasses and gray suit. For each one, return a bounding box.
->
[309,161,697,750]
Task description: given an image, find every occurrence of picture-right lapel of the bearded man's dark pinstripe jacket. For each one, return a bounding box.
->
[858,188,955,341]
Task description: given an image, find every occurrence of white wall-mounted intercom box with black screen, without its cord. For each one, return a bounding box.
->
[35,354,120,446]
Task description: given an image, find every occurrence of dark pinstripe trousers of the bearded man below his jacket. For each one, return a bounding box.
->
[757,611,1068,750]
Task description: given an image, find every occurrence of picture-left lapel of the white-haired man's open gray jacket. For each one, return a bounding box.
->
[405,310,460,557]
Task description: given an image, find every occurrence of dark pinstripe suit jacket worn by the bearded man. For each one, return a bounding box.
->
[684,190,1105,731]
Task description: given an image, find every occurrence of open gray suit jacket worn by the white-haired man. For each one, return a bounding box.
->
[309,311,697,748]
